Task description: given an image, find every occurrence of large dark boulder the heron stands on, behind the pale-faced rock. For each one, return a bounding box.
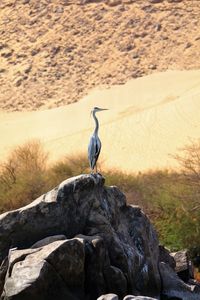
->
[0,175,160,299]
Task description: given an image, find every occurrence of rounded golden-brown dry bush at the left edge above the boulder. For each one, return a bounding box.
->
[0,140,48,211]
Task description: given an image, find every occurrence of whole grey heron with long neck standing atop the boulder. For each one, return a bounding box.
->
[88,107,108,173]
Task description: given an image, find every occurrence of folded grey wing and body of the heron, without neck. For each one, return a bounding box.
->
[88,136,101,169]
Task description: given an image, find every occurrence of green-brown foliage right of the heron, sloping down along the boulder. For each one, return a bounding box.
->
[105,170,200,251]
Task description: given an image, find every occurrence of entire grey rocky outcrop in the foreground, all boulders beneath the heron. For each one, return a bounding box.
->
[0,175,199,300]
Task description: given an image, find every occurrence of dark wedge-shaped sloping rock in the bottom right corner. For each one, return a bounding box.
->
[159,262,200,300]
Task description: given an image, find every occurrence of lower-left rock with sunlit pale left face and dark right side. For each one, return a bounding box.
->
[4,239,84,300]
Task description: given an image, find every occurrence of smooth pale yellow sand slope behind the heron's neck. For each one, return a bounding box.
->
[0,70,200,171]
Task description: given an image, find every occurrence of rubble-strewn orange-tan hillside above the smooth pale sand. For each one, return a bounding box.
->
[0,0,200,111]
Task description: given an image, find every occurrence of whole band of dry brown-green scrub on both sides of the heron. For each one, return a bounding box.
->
[0,141,200,255]
